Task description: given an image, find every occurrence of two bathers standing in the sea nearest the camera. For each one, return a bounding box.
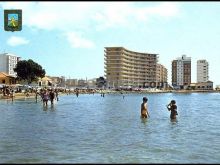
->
[141,97,178,120]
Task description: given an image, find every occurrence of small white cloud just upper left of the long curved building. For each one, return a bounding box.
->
[65,32,94,48]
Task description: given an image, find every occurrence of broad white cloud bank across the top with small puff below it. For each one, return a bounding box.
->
[0,2,179,47]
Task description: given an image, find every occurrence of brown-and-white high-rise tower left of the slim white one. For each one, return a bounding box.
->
[172,55,191,89]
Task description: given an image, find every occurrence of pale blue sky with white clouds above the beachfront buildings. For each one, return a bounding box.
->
[0,1,220,87]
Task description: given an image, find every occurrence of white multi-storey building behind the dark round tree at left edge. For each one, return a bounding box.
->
[0,53,20,77]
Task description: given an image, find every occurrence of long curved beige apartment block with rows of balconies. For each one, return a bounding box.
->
[104,47,158,88]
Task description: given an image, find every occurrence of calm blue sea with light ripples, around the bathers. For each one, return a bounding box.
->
[0,93,220,163]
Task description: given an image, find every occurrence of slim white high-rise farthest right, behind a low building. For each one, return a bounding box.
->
[197,60,209,83]
